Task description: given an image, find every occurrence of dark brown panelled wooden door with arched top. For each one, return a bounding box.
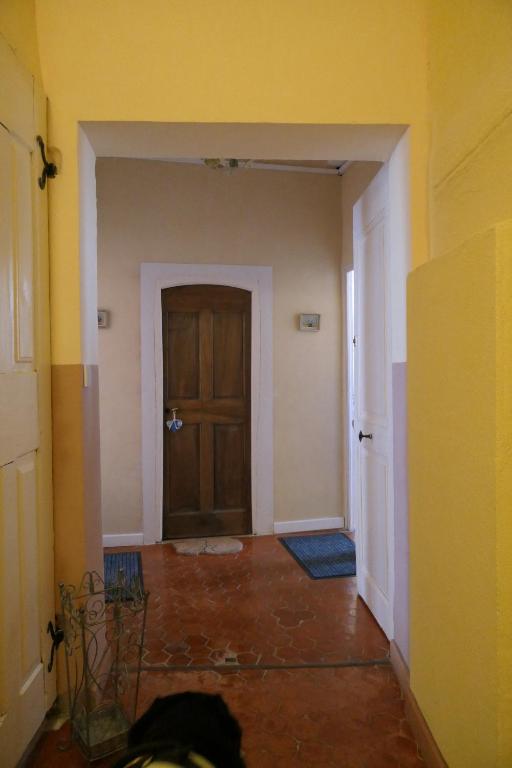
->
[162,285,252,539]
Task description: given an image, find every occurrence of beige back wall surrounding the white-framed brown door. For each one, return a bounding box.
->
[97,160,344,533]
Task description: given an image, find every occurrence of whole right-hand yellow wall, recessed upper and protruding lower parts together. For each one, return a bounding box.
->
[409,0,512,768]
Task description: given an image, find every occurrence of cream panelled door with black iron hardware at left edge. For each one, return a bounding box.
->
[0,39,55,768]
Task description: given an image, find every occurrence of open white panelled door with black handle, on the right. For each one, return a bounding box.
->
[354,166,393,638]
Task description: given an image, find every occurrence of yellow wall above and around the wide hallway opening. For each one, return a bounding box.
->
[36,0,428,363]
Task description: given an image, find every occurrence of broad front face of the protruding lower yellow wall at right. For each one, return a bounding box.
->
[408,232,497,768]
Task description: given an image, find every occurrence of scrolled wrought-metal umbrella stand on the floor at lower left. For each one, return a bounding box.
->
[59,570,148,760]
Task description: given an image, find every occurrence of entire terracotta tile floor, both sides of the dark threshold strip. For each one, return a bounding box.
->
[28,537,424,768]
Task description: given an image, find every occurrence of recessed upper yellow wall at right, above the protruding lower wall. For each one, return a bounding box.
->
[428,0,512,256]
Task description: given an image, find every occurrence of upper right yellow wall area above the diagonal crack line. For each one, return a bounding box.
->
[427,0,512,185]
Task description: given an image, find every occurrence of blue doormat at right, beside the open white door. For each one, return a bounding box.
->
[279,533,356,579]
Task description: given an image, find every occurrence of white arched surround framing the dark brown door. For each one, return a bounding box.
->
[140,262,274,544]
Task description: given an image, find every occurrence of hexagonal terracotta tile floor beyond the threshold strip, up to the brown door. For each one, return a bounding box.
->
[136,536,389,666]
